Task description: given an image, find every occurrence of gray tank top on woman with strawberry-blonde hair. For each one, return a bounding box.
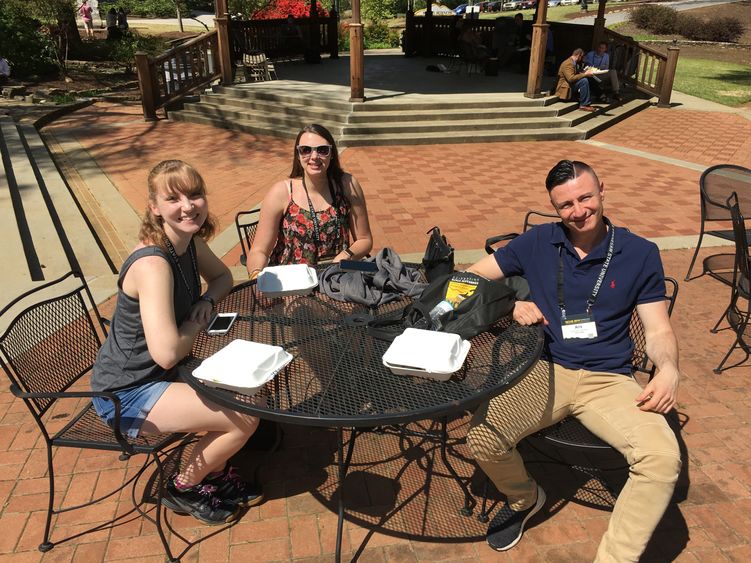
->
[91,241,200,391]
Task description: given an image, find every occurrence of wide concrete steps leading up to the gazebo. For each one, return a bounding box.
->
[169,80,649,147]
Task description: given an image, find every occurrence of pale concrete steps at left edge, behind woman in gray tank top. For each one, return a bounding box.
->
[0,116,114,307]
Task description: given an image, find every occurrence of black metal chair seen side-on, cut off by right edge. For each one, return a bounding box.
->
[713,192,751,373]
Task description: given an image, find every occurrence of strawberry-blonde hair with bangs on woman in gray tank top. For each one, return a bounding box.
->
[138,160,217,246]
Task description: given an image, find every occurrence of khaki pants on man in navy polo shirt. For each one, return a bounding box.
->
[467,361,681,562]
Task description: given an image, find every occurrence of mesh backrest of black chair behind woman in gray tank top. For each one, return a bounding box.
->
[0,272,106,419]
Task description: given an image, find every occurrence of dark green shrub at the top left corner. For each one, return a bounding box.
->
[0,11,59,78]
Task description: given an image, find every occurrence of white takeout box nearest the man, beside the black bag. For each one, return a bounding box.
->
[383,328,471,381]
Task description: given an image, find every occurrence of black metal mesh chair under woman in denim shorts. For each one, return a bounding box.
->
[0,272,185,559]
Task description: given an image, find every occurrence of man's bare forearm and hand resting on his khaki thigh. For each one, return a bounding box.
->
[636,301,680,414]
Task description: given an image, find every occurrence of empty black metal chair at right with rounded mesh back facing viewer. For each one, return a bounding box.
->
[685,164,751,281]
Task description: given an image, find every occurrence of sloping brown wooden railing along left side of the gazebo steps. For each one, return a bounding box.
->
[136,31,222,120]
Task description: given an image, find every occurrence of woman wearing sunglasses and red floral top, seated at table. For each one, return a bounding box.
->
[247,124,373,279]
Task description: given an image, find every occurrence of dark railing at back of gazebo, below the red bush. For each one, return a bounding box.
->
[230,14,339,61]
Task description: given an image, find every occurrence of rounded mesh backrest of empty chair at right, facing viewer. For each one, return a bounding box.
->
[699,164,751,221]
